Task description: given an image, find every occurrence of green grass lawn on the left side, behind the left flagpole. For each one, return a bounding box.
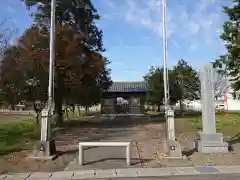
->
[0,112,99,156]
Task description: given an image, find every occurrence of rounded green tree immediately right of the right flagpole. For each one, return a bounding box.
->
[173,59,200,113]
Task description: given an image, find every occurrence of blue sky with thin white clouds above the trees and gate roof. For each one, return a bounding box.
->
[0,0,231,81]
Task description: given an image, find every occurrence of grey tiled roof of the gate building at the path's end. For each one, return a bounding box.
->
[107,81,148,92]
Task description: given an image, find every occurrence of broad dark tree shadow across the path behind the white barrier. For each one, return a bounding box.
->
[54,115,165,159]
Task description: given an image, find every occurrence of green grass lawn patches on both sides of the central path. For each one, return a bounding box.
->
[0,110,240,156]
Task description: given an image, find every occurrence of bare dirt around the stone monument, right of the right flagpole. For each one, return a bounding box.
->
[173,120,240,167]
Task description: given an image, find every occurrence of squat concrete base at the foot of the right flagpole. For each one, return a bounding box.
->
[164,140,183,159]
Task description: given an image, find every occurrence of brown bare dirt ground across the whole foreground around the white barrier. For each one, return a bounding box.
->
[0,115,240,174]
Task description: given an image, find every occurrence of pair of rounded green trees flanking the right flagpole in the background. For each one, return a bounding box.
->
[144,59,200,112]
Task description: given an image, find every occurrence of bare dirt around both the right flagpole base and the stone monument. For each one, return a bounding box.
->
[129,119,240,167]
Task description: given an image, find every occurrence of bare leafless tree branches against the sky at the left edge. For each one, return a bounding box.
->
[0,17,17,56]
